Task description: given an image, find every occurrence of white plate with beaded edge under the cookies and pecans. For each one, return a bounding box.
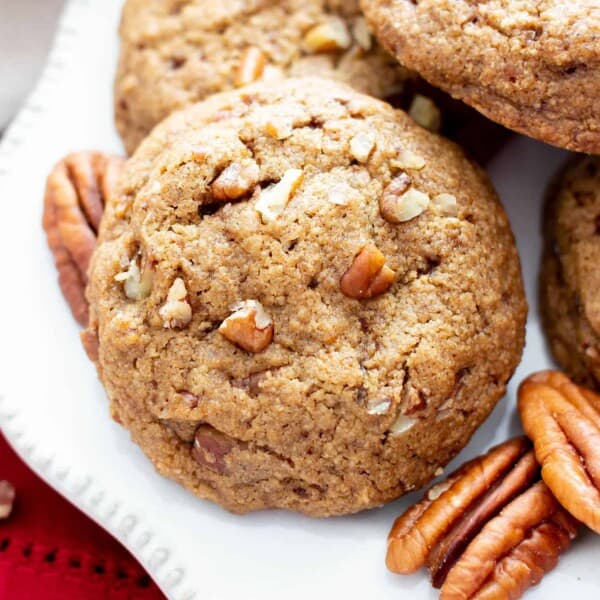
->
[0,0,600,600]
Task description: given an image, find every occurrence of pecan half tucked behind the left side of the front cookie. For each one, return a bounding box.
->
[42,152,124,326]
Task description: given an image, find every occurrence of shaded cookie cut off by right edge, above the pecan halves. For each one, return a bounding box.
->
[540,157,600,389]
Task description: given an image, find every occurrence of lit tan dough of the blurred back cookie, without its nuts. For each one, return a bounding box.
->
[115,0,414,152]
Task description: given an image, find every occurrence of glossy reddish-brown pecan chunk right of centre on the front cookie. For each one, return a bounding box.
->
[340,244,396,300]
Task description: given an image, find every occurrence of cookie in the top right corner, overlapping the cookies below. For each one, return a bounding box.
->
[361,0,600,153]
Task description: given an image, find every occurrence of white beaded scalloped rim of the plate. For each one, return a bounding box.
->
[0,0,197,600]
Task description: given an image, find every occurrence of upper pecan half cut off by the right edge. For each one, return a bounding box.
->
[519,371,600,533]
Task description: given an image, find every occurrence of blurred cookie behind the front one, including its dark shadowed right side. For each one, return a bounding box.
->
[115,0,507,164]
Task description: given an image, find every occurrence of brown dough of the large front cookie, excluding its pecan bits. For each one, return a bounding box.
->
[88,79,526,516]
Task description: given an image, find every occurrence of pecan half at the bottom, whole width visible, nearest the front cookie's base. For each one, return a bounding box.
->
[386,437,577,600]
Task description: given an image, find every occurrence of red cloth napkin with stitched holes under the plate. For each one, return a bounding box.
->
[0,434,164,600]
